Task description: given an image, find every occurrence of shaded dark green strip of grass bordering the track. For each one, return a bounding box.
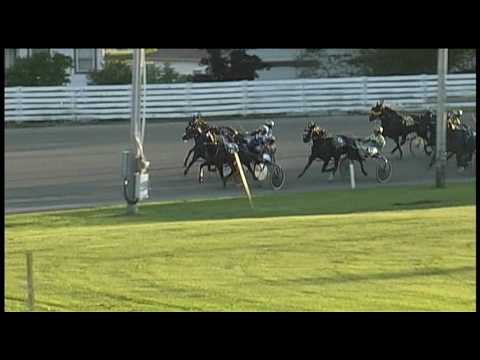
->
[5,182,476,231]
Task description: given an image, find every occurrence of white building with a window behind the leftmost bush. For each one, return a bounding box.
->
[5,49,105,86]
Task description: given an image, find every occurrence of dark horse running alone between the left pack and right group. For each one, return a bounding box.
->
[298,122,368,178]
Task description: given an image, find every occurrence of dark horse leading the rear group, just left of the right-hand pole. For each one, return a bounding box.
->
[369,100,419,159]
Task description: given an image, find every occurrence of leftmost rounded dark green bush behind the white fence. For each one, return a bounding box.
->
[5,53,72,86]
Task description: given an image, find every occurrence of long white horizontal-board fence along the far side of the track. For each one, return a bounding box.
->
[5,74,476,121]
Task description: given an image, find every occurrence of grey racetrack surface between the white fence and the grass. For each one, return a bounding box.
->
[5,114,475,213]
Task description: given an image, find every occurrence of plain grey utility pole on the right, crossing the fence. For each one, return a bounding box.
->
[435,49,448,188]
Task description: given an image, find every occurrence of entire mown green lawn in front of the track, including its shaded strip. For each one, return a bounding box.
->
[5,183,476,311]
